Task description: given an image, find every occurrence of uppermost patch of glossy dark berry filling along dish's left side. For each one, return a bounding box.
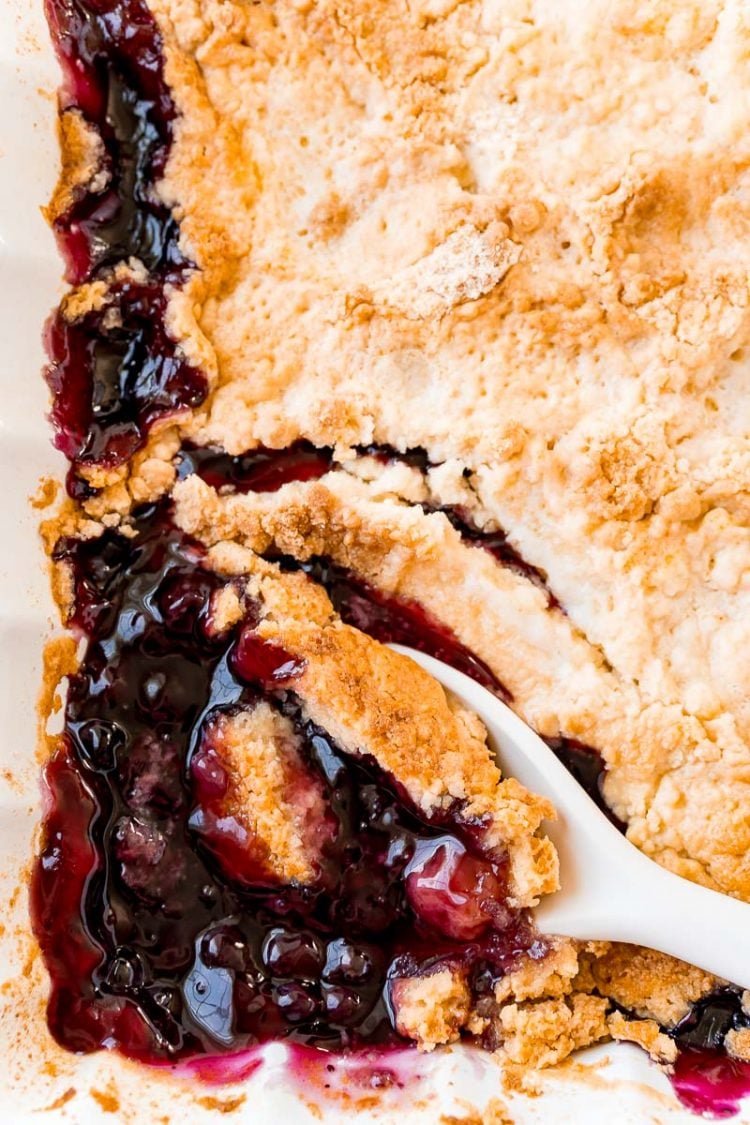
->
[46,0,188,285]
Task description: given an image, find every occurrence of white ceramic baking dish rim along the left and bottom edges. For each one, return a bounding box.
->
[0,0,737,1125]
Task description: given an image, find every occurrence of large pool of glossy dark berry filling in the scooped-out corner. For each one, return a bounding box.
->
[31,503,543,1061]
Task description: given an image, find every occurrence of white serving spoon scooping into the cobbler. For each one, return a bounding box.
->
[391,645,750,988]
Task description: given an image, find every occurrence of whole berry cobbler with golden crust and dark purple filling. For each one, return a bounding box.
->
[31,0,750,1108]
